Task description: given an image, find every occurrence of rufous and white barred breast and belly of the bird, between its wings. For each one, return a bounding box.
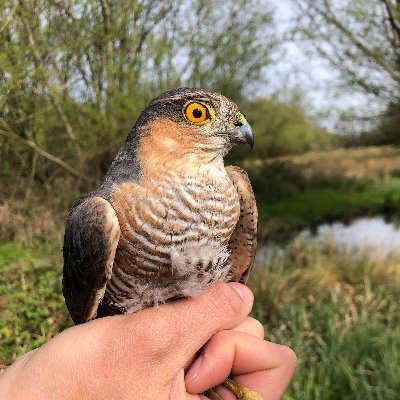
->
[104,170,240,313]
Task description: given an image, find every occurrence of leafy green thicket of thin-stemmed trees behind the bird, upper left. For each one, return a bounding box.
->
[0,0,276,200]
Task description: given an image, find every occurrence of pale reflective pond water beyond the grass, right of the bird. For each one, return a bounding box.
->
[256,216,400,263]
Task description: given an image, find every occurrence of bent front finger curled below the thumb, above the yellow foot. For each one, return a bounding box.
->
[185,331,296,399]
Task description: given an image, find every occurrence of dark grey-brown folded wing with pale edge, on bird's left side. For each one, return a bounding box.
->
[63,197,120,324]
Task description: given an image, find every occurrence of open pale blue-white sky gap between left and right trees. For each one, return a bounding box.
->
[267,0,382,131]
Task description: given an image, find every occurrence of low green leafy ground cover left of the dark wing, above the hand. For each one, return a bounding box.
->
[0,242,70,365]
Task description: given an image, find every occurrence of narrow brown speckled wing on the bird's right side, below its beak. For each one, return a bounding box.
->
[226,166,258,283]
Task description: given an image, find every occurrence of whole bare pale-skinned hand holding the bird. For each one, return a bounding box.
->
[0,283,296,400]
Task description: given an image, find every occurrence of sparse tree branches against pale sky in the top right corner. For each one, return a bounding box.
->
[291,0,400,105]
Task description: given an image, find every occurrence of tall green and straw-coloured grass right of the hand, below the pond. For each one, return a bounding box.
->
[251,239,400,400]
